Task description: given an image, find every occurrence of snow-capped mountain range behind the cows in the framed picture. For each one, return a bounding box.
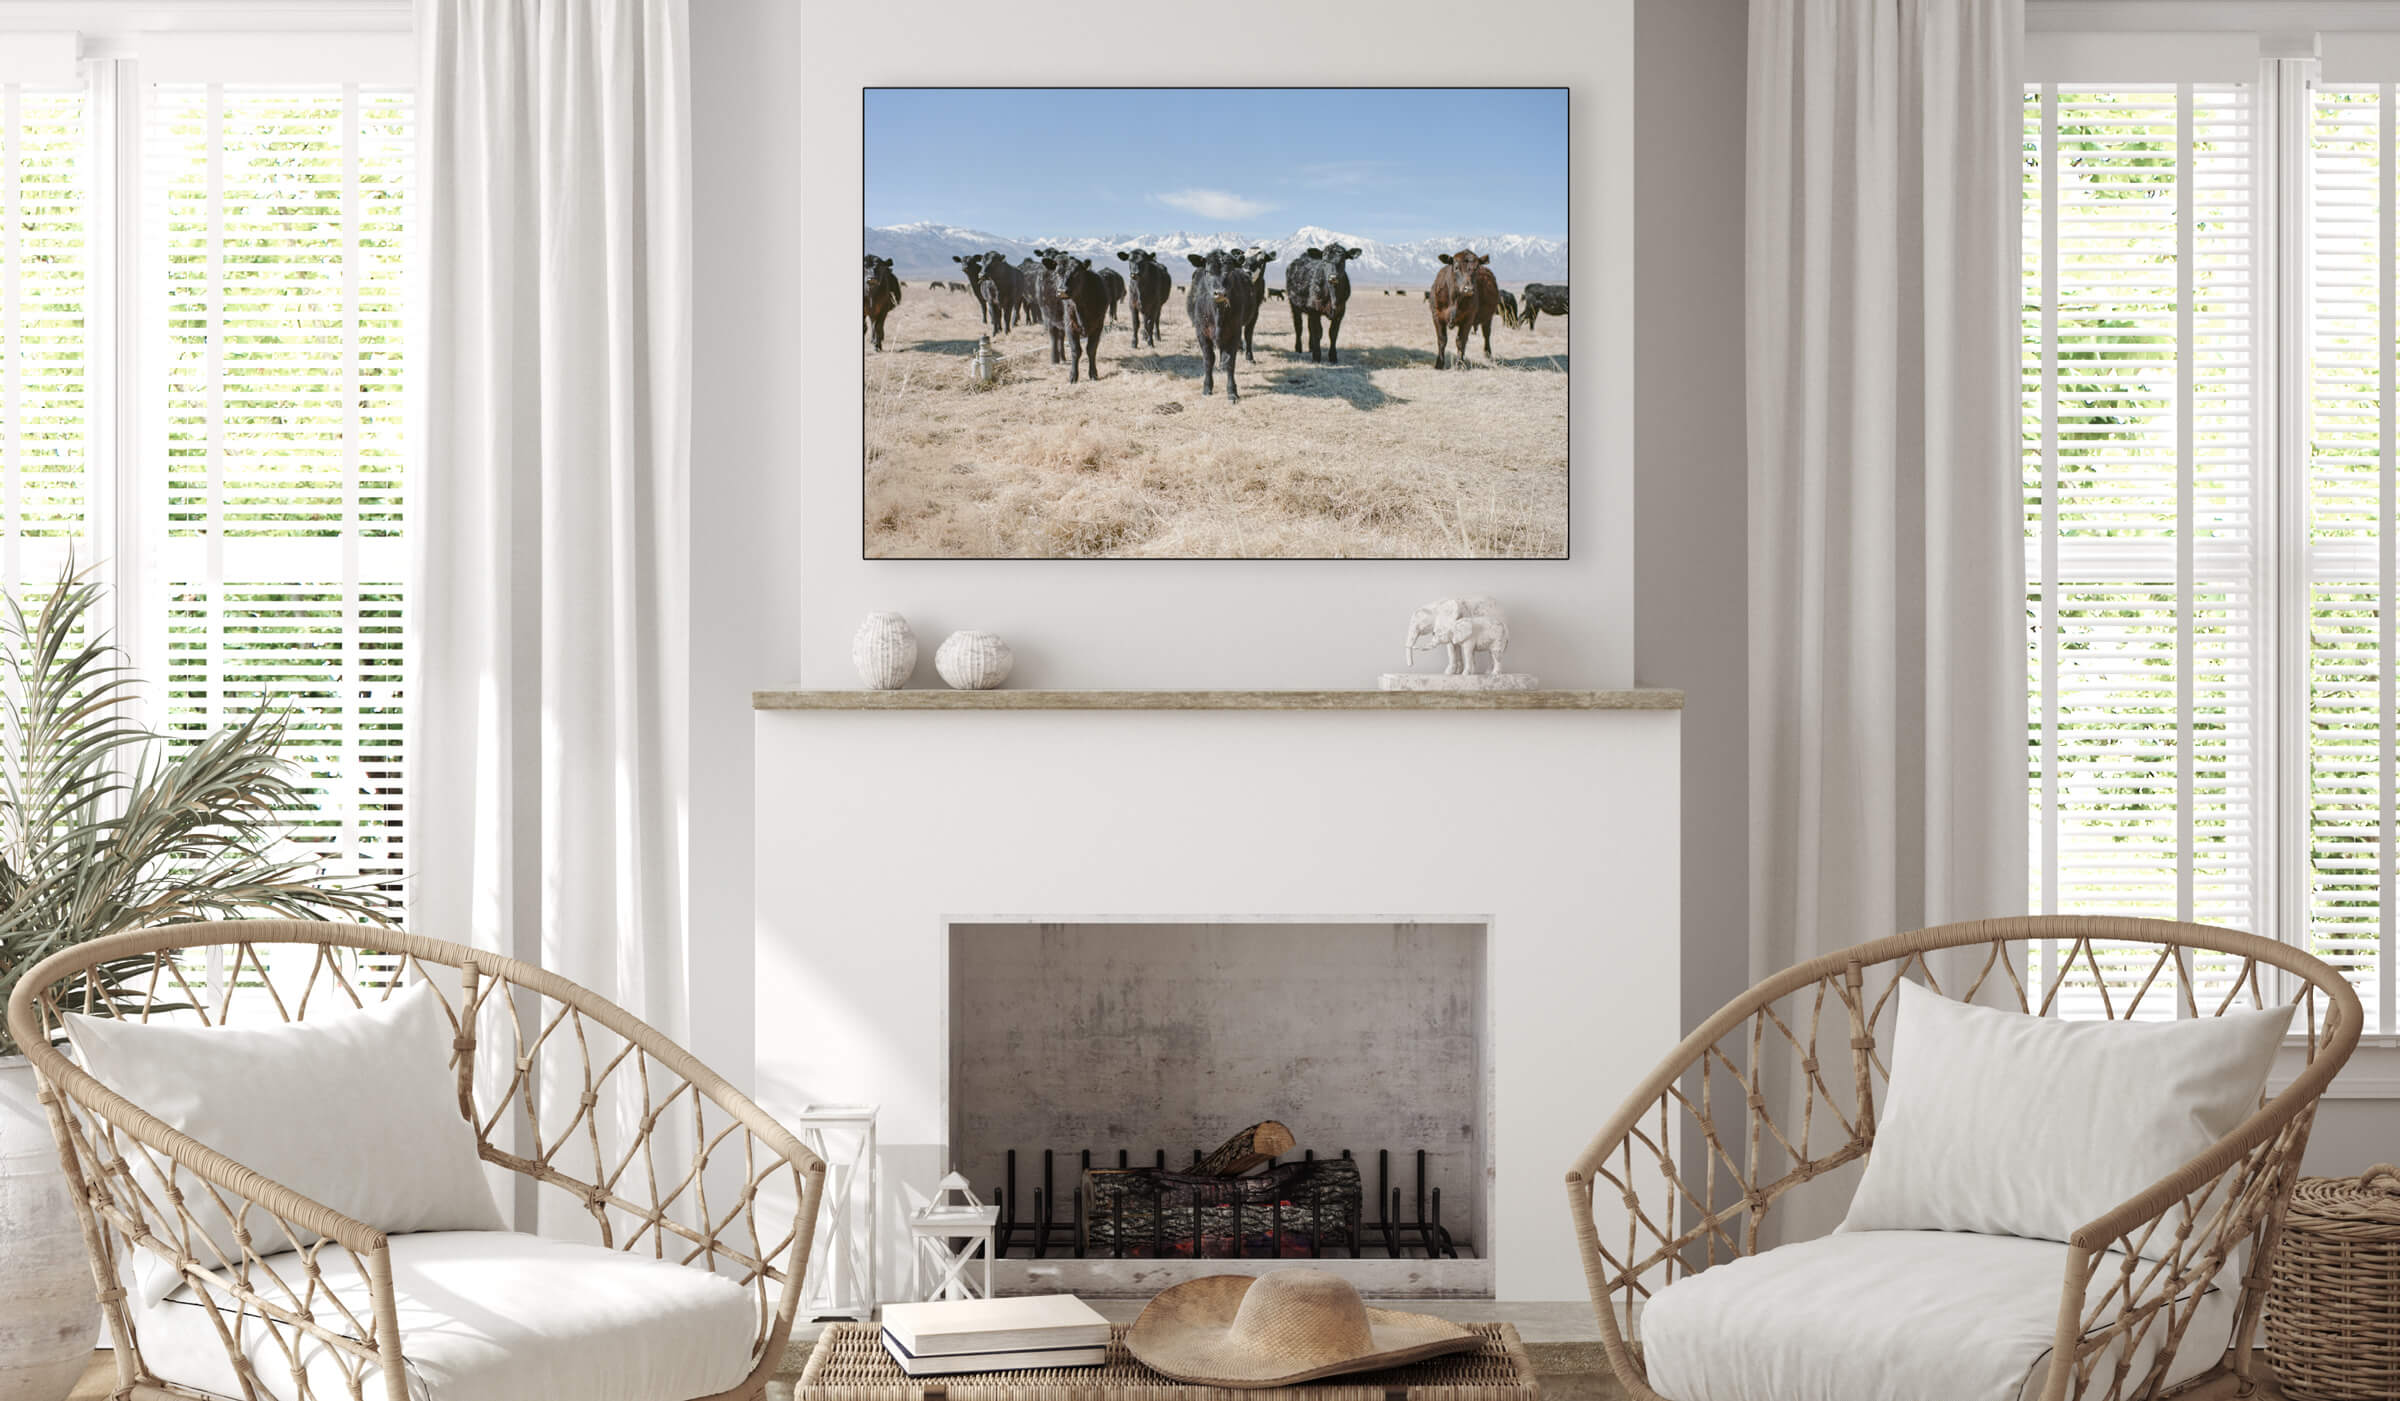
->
[866,223,1567,285]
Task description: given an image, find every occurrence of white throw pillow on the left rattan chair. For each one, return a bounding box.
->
[67,984,504,1300]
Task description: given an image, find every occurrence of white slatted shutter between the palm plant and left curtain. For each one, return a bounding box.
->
[139,76,415,878]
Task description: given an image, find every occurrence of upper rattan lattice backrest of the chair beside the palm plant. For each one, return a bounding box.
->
[10,919,821,1293]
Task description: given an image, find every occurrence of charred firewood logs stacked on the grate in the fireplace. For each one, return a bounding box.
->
[1082,1120,1361,1257]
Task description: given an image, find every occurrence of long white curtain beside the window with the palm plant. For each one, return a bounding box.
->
[408,0,691,1228]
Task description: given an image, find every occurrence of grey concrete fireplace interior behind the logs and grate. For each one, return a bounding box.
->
[948,919,1493,1295]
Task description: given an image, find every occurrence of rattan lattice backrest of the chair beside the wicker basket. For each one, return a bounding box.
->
[1570,916,2364,1329]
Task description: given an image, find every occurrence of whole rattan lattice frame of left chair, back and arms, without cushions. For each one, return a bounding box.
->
[7,919,826,1401]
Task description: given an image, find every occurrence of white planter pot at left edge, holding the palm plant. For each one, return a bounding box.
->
[0,1056,101,1401]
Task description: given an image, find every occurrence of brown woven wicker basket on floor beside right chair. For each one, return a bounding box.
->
[2266,1164,2400,1401]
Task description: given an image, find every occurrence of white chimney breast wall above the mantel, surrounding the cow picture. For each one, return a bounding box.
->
[787,0,1634,689]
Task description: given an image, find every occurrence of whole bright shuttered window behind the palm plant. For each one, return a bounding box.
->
[0,34,415,902]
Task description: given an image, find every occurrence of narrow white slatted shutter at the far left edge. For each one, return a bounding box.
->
[0,53,96,597]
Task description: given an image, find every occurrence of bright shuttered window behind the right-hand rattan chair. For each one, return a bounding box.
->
[2023,36,2400,1034]
